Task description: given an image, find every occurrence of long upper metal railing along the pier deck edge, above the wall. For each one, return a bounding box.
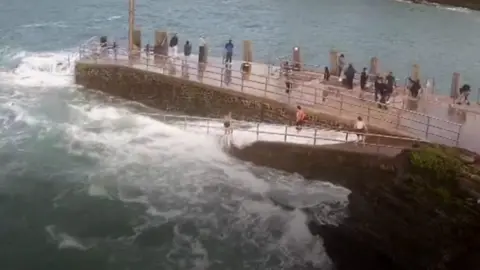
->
[80,43,462,145]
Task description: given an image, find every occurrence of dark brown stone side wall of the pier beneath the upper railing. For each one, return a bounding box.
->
[75,62,408,135]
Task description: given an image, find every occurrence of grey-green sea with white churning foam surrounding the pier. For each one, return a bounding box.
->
[0,0,480,270]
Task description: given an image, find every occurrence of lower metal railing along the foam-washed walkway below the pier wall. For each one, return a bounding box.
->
[155,115,425,153]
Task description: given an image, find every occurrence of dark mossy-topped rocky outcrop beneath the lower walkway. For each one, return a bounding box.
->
[232,142,480,270]
